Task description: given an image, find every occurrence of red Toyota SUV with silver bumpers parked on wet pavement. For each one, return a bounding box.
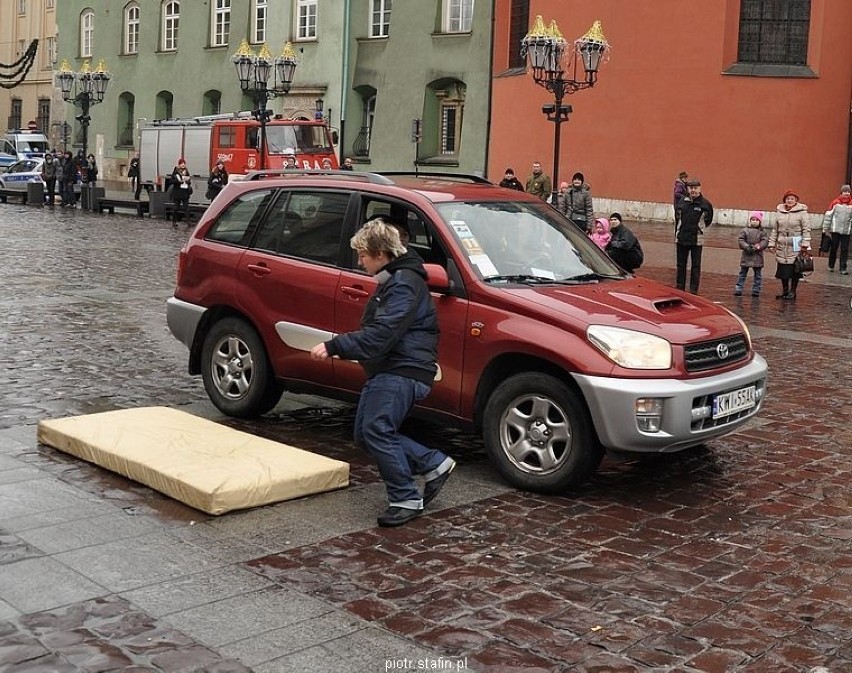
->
[168,171,767,493]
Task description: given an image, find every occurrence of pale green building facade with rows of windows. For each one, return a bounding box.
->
[57,0,493,178]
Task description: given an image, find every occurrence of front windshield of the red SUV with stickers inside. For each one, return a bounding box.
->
[436,201,624,283]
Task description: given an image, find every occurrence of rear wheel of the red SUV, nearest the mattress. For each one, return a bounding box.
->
[201,318,282,418]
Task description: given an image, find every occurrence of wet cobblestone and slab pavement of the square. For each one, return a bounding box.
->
[0,204,852,673]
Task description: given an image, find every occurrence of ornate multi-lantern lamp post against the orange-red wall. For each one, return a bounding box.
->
[521,15,610,205]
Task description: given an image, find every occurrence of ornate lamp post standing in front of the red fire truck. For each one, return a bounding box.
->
[232,40,296,169]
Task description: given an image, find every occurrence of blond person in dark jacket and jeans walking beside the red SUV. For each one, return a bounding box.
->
[311,218,456,526]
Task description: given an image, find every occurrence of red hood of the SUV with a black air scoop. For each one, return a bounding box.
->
[499,278,743,344]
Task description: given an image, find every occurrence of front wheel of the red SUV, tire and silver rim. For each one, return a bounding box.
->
[482,373,603,493]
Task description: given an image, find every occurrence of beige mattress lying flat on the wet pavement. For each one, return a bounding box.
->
[38,407,349,514]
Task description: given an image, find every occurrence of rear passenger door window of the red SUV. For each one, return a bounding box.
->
[254,191,349,264]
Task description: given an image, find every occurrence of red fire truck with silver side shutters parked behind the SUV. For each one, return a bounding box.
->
[139,113,340,185]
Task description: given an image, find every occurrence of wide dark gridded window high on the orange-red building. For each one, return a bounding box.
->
[737,0,811,65]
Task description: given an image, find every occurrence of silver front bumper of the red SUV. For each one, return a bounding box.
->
[574,354,767,453]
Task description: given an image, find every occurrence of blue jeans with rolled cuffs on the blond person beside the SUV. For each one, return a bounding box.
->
[355,374,447,509]
